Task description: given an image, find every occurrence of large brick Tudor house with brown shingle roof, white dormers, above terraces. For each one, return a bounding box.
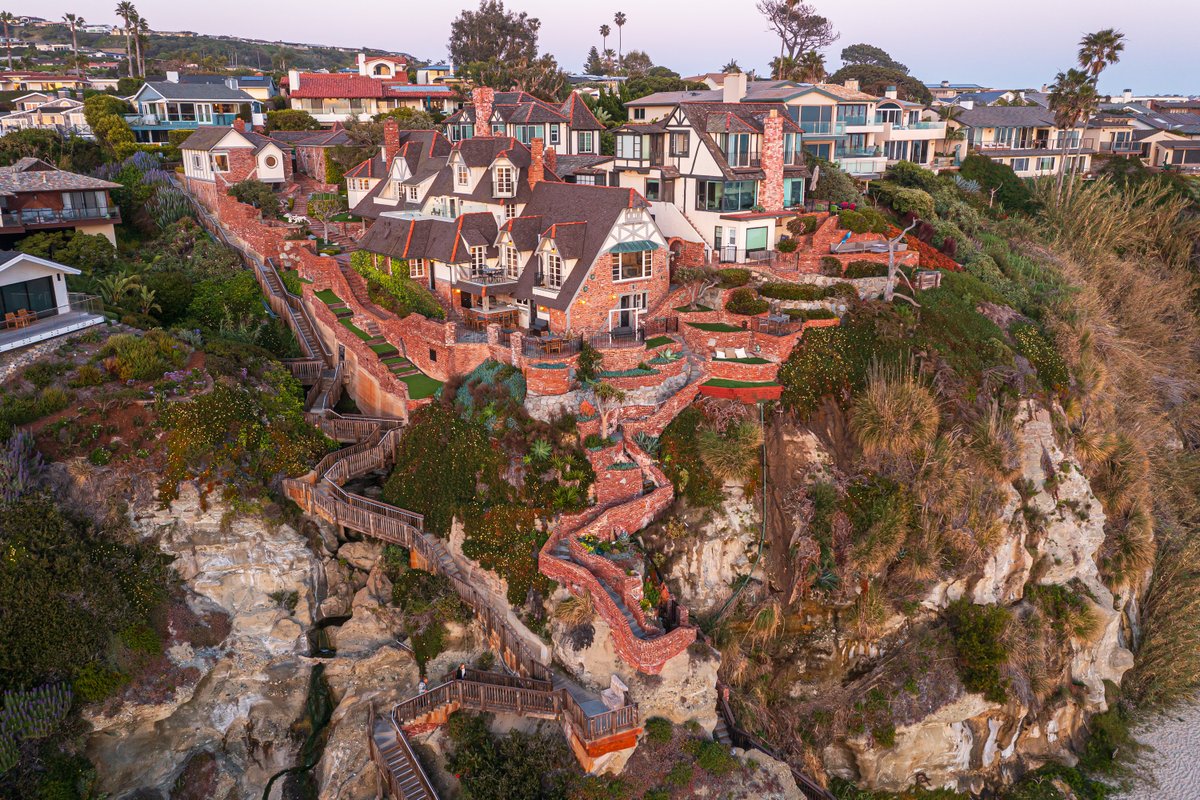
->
[348,117,670,335]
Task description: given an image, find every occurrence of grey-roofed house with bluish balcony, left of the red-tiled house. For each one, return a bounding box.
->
[126,74,265,144]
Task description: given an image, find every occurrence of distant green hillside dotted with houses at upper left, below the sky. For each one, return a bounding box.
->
[17,25,412,73]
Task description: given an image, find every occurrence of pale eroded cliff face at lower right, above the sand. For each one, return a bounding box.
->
[808,402,1133,790]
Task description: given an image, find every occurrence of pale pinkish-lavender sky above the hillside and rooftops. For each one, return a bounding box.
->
[10,0,1200,94]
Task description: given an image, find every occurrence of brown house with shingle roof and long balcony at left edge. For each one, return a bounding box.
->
[0,158,121,245]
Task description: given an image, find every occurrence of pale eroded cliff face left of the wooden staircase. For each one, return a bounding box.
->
[84,486,441,800]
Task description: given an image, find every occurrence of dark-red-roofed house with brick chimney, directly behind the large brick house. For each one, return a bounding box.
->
[445,89,605,156]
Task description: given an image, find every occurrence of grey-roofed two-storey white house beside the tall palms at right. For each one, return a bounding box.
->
[952,106,1097,178]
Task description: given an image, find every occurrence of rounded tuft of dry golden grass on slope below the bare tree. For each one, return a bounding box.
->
[850,363,941,457]
